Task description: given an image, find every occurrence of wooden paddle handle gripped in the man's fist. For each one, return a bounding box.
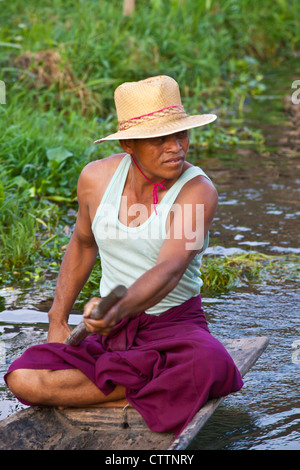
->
[64,285,127,346]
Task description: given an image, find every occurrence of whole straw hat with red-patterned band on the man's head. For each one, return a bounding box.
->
[94,75,217,144]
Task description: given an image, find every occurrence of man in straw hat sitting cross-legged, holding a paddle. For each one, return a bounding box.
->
[6,76,242,433]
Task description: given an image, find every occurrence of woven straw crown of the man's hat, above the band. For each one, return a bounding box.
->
[114,75,182,123]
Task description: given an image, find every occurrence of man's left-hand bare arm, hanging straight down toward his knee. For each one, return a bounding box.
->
[47,168,98,342]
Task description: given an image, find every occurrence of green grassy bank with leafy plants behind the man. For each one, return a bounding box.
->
[0,0,300,300]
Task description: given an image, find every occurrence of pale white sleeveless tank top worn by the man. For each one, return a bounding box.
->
[92,155,209,315]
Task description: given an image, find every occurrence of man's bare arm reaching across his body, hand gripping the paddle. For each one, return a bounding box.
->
[84,177,218,334]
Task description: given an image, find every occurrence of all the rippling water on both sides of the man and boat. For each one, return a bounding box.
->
[0,69,300,450]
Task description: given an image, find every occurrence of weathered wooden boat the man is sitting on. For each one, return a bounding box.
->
[0,337,268,451]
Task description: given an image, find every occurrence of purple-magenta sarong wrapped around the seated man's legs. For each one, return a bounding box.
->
[7,296,243,436]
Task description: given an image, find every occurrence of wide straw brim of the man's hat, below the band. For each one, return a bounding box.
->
[94,114,217,144]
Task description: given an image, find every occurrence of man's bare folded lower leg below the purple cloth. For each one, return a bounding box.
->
[6,369,125,407]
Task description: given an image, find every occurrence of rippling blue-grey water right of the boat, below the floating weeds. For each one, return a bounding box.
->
[191,285,300,450]
